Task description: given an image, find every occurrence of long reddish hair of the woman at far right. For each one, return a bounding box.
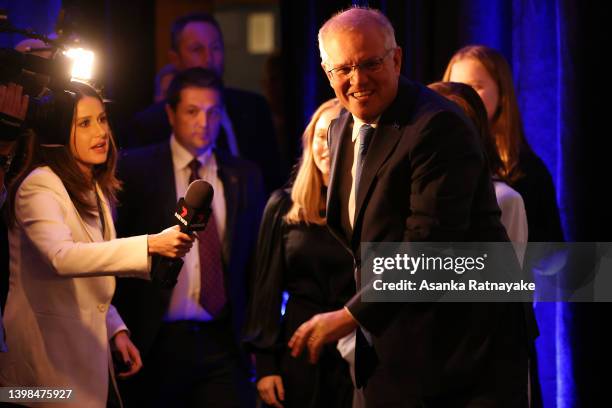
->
[442,45,531,184]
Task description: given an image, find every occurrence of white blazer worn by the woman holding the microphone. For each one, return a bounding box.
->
[0,167,150,408]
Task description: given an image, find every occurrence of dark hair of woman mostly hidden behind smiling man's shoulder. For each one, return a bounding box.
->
[428,82,507,181]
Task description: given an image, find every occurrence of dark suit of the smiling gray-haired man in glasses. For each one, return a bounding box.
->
[327,78,529,407]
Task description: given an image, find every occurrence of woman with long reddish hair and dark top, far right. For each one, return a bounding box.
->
[442,45,564,242]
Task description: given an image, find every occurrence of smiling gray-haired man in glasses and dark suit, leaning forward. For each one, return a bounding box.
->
[289,8,529,407]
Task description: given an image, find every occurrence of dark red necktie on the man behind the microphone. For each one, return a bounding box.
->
[189,159,227,317]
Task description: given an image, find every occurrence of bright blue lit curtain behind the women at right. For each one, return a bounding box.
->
[464,0,576,408]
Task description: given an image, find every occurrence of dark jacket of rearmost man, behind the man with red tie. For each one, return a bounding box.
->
[121,88,287,191]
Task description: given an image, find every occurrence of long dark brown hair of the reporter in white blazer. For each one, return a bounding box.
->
[8,82,121,225]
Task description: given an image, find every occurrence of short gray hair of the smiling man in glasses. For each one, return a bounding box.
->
[318,7,397,66]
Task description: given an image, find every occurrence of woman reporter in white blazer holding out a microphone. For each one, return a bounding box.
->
[0,82,194,408]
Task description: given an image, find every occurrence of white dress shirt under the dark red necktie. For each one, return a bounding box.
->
[164,135,226,321]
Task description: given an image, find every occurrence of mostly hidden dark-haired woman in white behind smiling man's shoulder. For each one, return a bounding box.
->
[428,82,528,264]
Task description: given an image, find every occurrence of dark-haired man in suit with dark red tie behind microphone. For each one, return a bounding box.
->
[114,68,264,407]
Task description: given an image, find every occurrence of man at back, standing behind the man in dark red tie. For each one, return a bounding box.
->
[122,13,287,191]
